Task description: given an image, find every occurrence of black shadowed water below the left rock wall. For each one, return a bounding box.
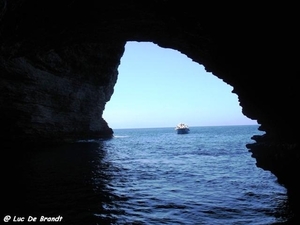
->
[2,142,116,224]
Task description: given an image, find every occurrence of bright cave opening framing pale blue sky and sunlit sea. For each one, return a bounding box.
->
[103,42,286,224]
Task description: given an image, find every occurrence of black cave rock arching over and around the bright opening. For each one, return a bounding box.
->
[0,0,300,216]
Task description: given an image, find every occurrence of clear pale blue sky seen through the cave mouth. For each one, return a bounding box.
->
[103,42,257,129]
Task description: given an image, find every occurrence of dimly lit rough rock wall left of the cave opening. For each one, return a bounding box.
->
[0,43,124,143]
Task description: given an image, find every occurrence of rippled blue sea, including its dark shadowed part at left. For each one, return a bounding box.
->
[1,125,289,225]
